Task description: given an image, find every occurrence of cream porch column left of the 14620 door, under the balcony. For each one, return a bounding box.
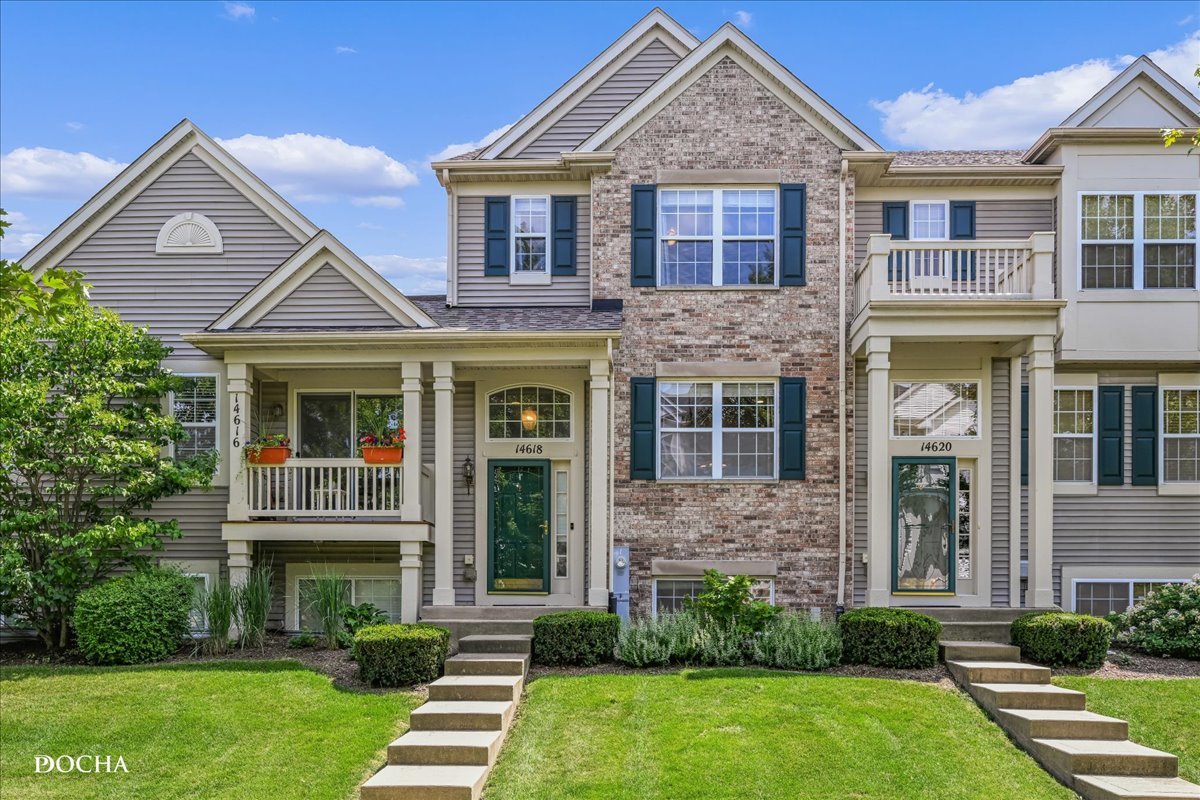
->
[866,336,892,606]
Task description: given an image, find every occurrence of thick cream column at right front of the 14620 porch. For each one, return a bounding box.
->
[1025,336,1054,608]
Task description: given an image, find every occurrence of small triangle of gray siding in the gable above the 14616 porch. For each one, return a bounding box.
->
[254,264,397,327]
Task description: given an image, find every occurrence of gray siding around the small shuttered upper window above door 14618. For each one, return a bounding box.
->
[455,194,592,306]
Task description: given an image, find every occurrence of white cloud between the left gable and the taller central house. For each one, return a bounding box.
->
[220,133,416,207]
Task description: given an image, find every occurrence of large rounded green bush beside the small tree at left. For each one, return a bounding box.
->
[73,569,193,664]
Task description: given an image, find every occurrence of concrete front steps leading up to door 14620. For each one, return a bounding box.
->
[941,633,1200,800]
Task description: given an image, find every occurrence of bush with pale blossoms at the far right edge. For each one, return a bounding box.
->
[1117,576,1200,660]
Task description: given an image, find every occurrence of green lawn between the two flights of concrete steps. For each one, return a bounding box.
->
[485,669,1074,800]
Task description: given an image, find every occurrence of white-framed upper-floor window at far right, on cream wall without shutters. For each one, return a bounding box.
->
[1079,192,1196,289]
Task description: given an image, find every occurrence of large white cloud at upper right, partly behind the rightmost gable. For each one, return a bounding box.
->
[871,31,1200,150]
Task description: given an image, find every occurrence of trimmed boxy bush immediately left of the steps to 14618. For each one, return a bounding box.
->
[352,625,450,686]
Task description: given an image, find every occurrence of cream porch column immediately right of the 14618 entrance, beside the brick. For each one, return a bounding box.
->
[588,359,612,608]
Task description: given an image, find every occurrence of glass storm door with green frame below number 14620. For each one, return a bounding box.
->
[892,458,958,595]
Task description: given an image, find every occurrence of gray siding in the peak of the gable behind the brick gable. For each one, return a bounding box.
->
[514,40,679,158]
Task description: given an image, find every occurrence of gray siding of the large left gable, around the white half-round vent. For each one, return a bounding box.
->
[61,154,300,356]
